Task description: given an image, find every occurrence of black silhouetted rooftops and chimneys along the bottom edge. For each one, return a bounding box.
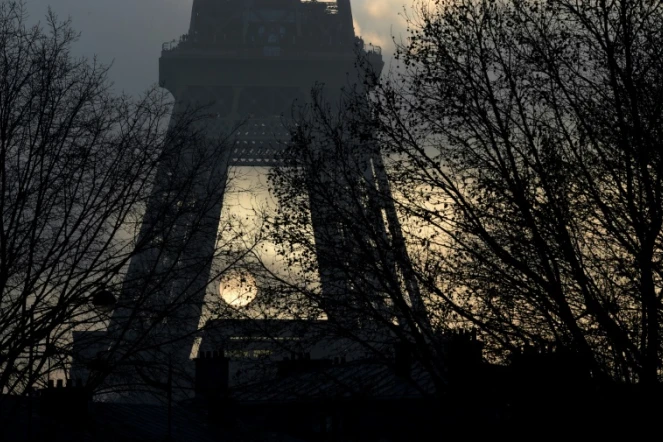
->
[0,336,661,441]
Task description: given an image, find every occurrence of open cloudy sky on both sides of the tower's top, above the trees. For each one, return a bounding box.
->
[26,0,413,94]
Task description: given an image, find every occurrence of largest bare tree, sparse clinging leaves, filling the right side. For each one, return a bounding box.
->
[264,0,663,385]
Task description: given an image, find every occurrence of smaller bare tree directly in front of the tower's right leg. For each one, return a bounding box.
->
[260,83,452,391]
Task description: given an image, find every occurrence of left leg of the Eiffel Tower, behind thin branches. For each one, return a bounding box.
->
[102,113,230,400]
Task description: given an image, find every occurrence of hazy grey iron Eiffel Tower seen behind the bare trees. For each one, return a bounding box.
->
[76,0,426,400]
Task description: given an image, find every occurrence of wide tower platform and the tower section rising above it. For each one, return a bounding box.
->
[159,0,384,98]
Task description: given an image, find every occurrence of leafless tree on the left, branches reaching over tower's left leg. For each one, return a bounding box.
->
[0,2,250,394]
